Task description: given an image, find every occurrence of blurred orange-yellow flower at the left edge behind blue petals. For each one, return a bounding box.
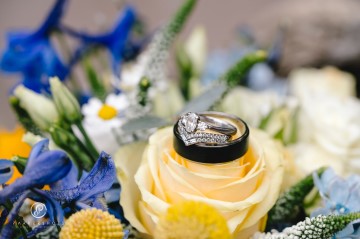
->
[0,127,31,184]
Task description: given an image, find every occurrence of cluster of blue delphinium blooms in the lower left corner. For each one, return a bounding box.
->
[0,139,115,238]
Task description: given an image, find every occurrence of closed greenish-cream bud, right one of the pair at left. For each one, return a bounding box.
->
[50,77,81,123]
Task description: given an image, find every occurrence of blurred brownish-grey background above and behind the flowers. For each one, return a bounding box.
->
[0,0,360,129]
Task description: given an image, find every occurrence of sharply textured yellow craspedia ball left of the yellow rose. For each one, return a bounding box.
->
[60,208,124,239]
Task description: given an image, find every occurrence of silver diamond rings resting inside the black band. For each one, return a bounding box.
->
[178,112,237,146]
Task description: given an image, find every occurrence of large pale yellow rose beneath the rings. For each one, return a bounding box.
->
[115,127,284,238]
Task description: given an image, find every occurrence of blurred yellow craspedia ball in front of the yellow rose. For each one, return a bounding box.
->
[155,201,232,239]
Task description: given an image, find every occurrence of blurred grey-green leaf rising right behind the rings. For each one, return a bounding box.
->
[179,83,227,115]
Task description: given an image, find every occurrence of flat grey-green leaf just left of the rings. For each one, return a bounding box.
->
[121,115,170,133]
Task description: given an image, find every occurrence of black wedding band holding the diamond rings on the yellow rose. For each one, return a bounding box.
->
[173,111,249,164]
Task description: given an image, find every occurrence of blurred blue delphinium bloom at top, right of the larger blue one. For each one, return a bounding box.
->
[60,6,136,77]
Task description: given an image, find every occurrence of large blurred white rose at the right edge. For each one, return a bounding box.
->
[290,68,360,173]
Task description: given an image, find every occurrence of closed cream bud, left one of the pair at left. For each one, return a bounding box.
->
[14,85,60,130]
